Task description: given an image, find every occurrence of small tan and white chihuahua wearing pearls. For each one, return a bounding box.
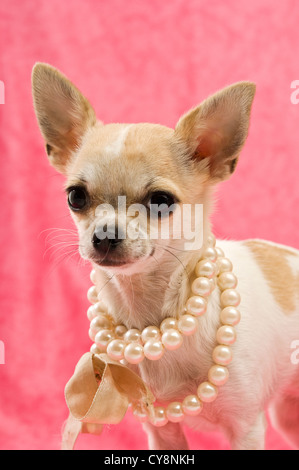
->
[33,63,299,450]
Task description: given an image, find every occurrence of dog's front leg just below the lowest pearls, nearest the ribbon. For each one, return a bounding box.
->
[143,422,189,450]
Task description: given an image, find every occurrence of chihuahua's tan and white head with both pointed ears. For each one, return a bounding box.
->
[32,64,255,274]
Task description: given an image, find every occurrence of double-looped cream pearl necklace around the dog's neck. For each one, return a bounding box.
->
[87,235,241,426]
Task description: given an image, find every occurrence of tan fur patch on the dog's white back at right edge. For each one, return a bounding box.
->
[244,240,299,315]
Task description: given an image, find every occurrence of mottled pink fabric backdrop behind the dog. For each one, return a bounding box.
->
[0,0,299,449]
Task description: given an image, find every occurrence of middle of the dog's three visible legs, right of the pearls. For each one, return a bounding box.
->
[231,412,267,450]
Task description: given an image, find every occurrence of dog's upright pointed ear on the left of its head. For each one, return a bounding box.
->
[32,63,96,173]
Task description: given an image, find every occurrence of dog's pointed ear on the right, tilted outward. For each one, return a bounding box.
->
[175,82,255,182]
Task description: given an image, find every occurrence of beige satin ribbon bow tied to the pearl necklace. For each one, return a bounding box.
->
[62,353,154,450]
